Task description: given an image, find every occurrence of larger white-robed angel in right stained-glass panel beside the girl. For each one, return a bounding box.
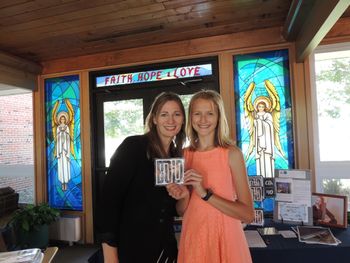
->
[244,80,284,177]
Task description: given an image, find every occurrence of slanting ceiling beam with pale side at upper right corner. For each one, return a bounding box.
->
[296,0,350,62]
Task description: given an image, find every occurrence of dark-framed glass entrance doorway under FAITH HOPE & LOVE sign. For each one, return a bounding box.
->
[90,57,219,237]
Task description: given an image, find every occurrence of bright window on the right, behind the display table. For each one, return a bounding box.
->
[311,43,350,208]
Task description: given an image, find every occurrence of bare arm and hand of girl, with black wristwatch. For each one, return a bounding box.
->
[185,147,254,223]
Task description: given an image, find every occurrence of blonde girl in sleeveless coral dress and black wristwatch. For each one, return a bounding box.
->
[168,90,254,263]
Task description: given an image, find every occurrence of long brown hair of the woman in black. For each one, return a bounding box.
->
[145,92,186,158]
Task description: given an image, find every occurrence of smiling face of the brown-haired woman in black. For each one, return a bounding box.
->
[153,100,184,142]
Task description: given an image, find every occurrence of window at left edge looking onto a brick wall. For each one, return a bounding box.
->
[0,92,35,203]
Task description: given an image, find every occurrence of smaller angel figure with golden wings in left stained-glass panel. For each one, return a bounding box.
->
[52,99,75,191]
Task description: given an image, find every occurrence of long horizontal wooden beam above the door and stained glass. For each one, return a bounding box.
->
[43,27,285,74]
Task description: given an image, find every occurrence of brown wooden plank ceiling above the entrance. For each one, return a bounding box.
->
[0,0,350,63]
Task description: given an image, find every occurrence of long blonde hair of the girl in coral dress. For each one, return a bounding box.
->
[186,90,234,150]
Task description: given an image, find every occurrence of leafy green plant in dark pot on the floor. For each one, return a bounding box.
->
[10,203,60,249]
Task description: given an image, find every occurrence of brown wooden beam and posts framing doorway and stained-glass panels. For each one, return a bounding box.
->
[35,18,350,243]
